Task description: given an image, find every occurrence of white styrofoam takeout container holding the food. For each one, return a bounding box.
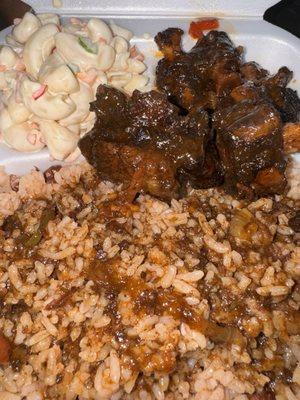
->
[0,0,300,174]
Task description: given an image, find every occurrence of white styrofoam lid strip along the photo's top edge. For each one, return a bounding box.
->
[26,0,276,18]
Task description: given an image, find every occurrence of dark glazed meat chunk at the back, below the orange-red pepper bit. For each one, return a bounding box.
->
[155,28,242,110]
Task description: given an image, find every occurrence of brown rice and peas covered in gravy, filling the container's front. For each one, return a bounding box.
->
[0,163,300,400]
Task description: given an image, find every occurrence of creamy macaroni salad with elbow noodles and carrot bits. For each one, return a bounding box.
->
[0,13,148,161]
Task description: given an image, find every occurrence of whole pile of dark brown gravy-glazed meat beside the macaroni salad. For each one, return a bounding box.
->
[79,28,300,200]
